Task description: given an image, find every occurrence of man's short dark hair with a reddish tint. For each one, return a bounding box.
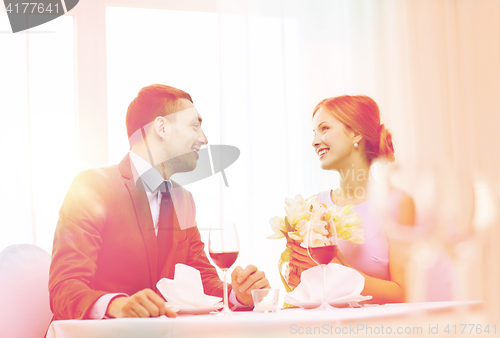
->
[126,84,193,140]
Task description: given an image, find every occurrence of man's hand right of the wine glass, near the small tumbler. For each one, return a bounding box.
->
[231,265,271,305]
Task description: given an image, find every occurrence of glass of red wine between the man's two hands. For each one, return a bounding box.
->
[208,223,240,315]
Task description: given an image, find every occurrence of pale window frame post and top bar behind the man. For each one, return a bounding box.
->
[66,0,217,171]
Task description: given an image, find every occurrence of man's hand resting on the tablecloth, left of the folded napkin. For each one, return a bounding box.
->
[106,289,177,318]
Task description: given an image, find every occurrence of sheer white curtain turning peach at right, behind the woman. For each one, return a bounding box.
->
[218,0,500,310]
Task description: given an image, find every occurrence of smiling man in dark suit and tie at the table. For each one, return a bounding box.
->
[49,85,269,320]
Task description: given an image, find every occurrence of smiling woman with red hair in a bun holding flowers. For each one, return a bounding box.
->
[288,95,415,304]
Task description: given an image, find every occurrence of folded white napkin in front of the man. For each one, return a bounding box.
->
[156,264,222,308]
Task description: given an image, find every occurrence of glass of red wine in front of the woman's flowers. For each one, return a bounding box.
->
[306,222,338,310]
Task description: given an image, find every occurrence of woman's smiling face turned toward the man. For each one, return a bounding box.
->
[312,107,354,170]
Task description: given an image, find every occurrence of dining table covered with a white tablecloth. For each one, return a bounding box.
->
[47,301,492,338]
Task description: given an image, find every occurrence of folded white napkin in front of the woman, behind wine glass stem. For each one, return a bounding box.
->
[285,263,371,305]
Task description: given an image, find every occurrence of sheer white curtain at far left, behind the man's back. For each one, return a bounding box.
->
[0,12,76,252]
